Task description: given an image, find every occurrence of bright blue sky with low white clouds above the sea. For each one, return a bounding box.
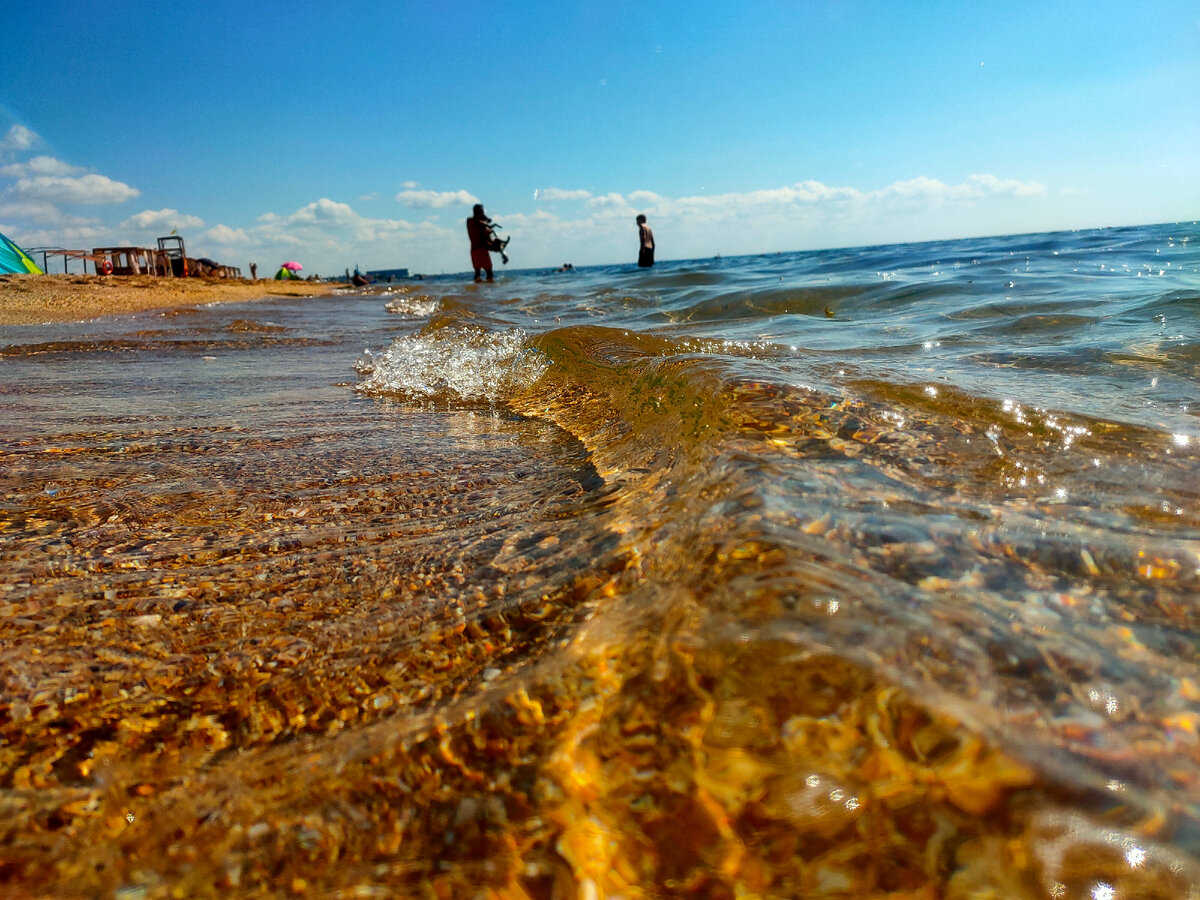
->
[0,0,1200,274]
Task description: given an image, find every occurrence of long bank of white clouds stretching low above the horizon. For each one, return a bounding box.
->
[0,154,1048,274]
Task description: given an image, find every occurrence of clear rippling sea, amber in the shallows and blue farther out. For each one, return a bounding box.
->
[0,222,1200,900]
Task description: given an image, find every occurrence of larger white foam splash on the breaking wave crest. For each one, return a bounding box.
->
[355,329,548,403]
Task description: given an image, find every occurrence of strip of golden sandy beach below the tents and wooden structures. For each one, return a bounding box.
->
[0,275,336,325]
